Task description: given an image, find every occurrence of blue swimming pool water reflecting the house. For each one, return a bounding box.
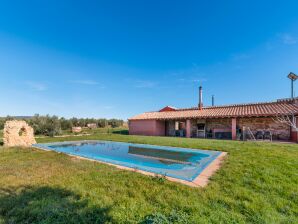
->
[34,141,221,181]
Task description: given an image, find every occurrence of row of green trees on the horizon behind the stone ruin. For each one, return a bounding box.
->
[0,114,124,136]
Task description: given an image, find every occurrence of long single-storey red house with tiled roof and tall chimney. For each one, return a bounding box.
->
[129,87,298,141]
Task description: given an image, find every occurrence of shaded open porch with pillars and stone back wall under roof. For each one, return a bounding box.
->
[165,117,292,141]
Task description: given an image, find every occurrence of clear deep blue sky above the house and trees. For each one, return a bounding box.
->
[0,0,298,119]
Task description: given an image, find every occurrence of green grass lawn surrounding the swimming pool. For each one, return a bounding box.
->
[0,134,298,223]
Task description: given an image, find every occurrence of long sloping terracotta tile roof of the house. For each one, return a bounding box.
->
[129,100,298,120]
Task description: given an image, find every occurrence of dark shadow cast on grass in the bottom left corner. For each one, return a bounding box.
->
[0,187,113,223]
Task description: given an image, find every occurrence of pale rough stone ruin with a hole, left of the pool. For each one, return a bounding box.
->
[3,120,36,147]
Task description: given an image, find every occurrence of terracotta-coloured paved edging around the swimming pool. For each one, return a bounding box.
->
[32,140,227,187]
